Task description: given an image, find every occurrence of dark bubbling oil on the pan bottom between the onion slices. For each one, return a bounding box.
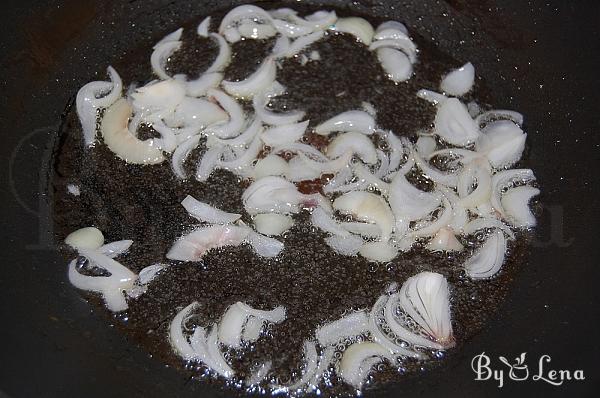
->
[53,3,527,394]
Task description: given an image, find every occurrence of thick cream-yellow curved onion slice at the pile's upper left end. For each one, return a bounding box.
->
[101,99,165,164]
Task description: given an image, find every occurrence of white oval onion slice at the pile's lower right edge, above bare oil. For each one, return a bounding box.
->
[464,231,506,279]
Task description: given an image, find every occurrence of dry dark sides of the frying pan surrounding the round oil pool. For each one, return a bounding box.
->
[0,0,600,398]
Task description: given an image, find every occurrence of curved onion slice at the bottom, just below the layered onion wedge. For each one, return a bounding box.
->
[340,342,393,389]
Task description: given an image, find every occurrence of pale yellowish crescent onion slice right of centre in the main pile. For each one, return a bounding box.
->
[333,191,394,241]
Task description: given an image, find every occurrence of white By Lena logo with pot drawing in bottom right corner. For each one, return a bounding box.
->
[471,352,585,388]
